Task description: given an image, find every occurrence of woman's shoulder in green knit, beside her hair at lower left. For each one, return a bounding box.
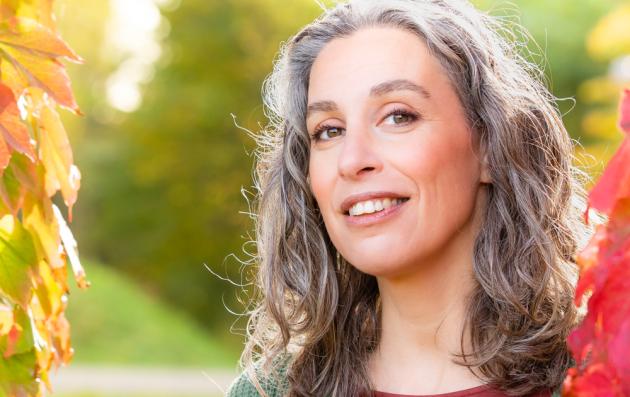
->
[226,360,288,397]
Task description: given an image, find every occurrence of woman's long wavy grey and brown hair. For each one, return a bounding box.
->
[241,0,588,396]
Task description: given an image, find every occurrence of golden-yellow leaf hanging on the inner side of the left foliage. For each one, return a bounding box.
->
[40,106,81,211]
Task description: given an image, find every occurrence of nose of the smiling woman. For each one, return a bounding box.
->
[337,125,382,179]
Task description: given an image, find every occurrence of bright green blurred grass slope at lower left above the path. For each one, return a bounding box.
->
[66,263,239,368]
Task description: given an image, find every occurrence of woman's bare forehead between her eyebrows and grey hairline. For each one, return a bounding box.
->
[308,27,448,102]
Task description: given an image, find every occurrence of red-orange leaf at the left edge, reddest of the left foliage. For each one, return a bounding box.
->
[0,83,35,161]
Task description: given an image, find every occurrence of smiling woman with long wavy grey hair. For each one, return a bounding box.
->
[228,0,585,397]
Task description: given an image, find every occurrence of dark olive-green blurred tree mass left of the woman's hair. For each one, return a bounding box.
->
[69,0,326,346]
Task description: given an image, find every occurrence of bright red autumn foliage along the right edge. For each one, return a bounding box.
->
[564,90,630,397]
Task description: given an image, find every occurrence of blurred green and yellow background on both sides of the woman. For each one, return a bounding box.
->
[49,0,630,390]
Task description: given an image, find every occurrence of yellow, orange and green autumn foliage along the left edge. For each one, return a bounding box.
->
[0,0,87,397]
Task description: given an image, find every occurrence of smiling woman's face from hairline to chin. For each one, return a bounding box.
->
[307,27,487,277]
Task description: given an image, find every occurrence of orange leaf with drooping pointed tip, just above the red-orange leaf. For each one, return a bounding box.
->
[0,44,81,114]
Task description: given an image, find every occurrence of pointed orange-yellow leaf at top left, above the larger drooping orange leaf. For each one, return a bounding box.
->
[0,17,83,63]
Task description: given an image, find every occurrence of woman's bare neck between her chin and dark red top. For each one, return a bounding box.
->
[369,193,483,394]
